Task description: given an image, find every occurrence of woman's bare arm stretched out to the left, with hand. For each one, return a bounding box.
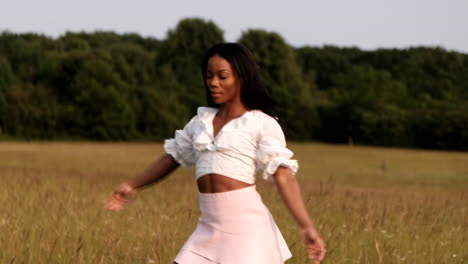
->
[105,154,179,211]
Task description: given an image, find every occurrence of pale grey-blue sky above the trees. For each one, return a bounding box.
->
[0,0,468,54]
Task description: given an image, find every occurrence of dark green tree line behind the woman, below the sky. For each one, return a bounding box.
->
[0,18,468,150]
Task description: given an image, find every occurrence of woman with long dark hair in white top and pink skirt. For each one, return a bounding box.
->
[106,43,325,264]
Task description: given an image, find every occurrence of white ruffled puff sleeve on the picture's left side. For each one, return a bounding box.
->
[164,116,198,167]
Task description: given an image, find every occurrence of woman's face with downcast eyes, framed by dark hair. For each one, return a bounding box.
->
[206,55,241,105]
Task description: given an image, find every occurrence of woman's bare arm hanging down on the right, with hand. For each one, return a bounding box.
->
[274,167,325,264]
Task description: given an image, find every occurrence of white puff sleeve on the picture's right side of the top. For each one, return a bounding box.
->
[257,117,299,180]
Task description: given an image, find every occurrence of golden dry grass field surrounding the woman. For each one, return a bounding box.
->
[0,142,468,264]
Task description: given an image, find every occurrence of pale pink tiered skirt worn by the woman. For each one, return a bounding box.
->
[174,185,291,264]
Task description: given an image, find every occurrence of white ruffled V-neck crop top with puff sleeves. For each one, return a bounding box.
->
[164,107,298,184]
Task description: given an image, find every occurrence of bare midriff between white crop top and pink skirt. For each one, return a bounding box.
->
[197,174,254,193]
